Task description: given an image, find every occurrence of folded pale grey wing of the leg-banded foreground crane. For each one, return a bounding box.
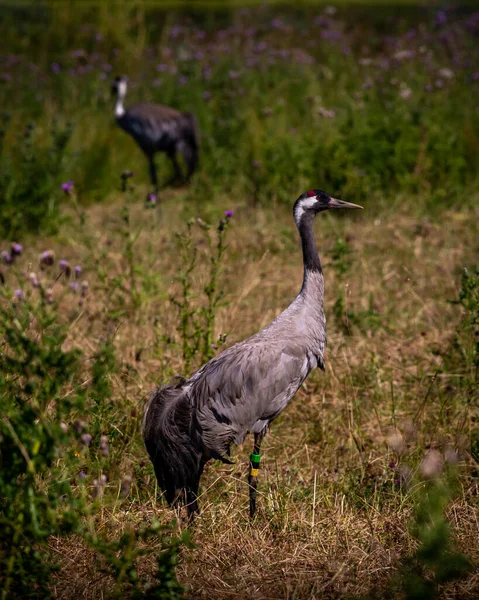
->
[187,340,310,455]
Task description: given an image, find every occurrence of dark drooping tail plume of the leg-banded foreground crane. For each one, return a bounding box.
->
[143,380,204,513]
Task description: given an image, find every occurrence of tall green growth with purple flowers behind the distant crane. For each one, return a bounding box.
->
[0,3,479,231]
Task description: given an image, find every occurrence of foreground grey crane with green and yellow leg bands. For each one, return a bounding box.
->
[143,190,362,517]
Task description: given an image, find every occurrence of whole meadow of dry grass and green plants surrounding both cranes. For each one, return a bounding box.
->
[0,2,479,600]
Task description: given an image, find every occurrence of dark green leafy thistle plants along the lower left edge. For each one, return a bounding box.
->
[0,255,187,600]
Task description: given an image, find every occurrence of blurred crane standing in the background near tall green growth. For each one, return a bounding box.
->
[111,77,199,192]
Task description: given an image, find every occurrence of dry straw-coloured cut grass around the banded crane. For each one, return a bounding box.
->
[31,192,479,599]
